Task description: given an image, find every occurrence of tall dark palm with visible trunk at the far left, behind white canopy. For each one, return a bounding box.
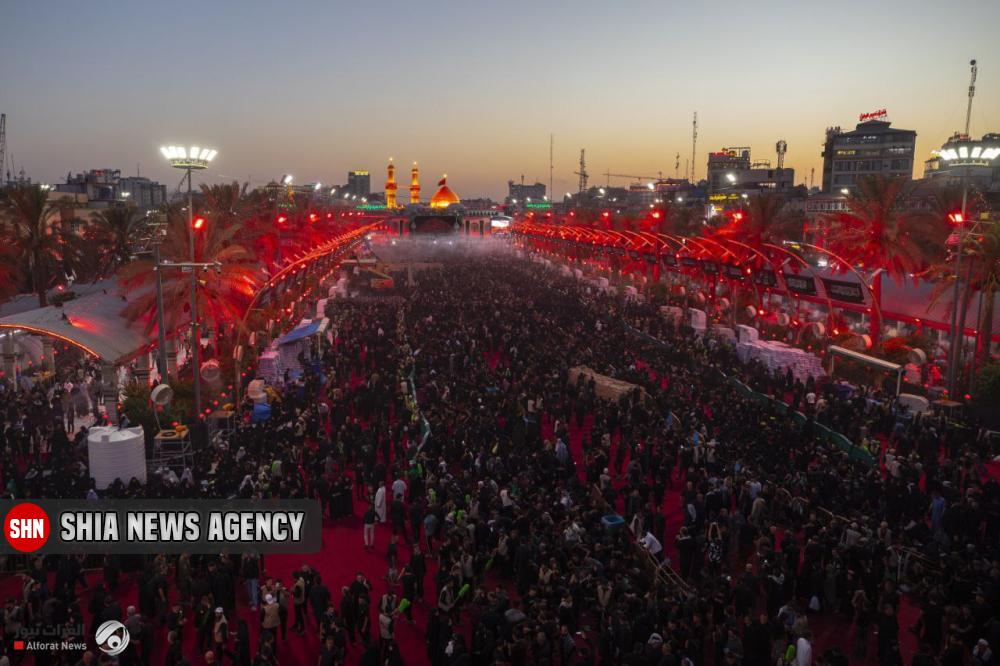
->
[0,184,84,307]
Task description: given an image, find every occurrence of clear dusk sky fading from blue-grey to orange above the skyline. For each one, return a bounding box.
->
[0,0,1000,197]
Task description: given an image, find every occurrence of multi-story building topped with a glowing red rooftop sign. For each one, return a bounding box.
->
[823,111,917,193]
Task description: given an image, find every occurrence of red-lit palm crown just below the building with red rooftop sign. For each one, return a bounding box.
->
[829,176,947,280]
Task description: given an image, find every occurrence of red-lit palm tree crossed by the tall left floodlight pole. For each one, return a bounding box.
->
[119,209,261,352]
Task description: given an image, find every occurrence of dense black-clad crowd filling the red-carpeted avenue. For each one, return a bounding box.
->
[0,244,1000,666]
